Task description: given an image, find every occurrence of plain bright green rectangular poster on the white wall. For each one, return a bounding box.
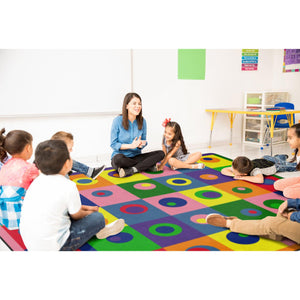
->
[178,49,206,80]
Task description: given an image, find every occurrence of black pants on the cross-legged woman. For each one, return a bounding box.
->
[111,150,165,172]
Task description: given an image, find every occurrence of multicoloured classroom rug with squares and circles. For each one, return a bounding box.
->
[0,153,300,251]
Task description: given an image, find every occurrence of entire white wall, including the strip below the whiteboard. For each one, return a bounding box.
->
[0,49,300,165]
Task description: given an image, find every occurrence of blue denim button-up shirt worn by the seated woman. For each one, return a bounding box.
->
[110,116,147,158]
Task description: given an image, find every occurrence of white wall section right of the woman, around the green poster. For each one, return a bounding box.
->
[133,49,300,152]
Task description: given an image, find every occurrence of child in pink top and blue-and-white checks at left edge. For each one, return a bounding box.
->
[0,128,39,230]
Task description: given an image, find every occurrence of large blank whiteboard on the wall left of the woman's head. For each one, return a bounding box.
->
[0,49,131,116]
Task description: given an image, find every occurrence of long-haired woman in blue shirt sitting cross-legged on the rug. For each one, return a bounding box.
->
[110,93,165,177]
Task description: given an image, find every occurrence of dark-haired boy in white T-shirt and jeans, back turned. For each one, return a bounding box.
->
[20,140,125,250]
